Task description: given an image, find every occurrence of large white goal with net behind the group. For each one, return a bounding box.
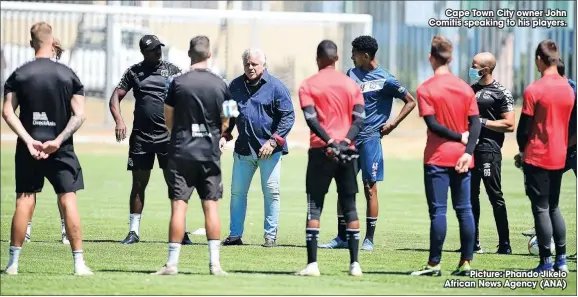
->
[1,1,373,141]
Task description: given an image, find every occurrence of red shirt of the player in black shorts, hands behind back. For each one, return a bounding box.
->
[299,68,364,148]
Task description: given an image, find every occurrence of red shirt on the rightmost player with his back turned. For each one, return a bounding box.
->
[522,74,574,170]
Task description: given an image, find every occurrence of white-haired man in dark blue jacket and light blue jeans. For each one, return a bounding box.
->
[220,49,295,247]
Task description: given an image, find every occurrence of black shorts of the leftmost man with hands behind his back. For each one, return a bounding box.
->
[14,147,84,194]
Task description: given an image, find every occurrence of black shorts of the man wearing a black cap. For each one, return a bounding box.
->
[126,132,169,171]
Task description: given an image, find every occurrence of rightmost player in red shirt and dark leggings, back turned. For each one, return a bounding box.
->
[514,39,575,272]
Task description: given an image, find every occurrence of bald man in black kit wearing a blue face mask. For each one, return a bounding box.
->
[454,52,515,254]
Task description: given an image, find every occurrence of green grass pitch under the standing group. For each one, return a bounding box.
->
[0,144,576,295]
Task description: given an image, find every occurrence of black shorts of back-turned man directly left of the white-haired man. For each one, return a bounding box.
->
[166,158,223,200]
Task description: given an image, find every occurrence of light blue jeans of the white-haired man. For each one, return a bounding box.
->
[229,152,282,239]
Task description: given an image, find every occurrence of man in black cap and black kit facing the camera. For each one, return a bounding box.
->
[109,35,192,244]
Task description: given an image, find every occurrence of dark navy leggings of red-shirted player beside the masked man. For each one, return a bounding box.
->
[424,165,476,263]
